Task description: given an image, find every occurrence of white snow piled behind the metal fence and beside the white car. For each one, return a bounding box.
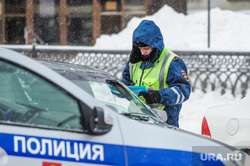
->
[93,5,250,134]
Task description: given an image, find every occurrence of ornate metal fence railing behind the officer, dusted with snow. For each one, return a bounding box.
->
[3,47,250,97]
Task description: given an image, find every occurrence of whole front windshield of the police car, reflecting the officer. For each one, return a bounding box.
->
[50,66,159,121]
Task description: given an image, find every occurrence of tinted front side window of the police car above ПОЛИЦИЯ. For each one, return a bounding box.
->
[0,60,83,131]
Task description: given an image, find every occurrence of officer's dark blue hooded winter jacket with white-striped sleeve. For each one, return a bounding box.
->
[122,20,191,127]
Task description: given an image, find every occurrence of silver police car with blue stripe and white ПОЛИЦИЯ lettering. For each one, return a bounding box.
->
[0,48,250,166]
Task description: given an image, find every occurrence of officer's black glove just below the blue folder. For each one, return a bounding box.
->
[138,90,161,104]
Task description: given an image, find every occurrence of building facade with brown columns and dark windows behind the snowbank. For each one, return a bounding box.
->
[0,0,186,46]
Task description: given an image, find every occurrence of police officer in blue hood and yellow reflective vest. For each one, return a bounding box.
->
[122,20,191,127]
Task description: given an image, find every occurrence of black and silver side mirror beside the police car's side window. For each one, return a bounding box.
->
[88,107,113,135]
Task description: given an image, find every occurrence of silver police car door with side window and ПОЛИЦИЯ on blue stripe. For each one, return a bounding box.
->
[0,52,125,166]
